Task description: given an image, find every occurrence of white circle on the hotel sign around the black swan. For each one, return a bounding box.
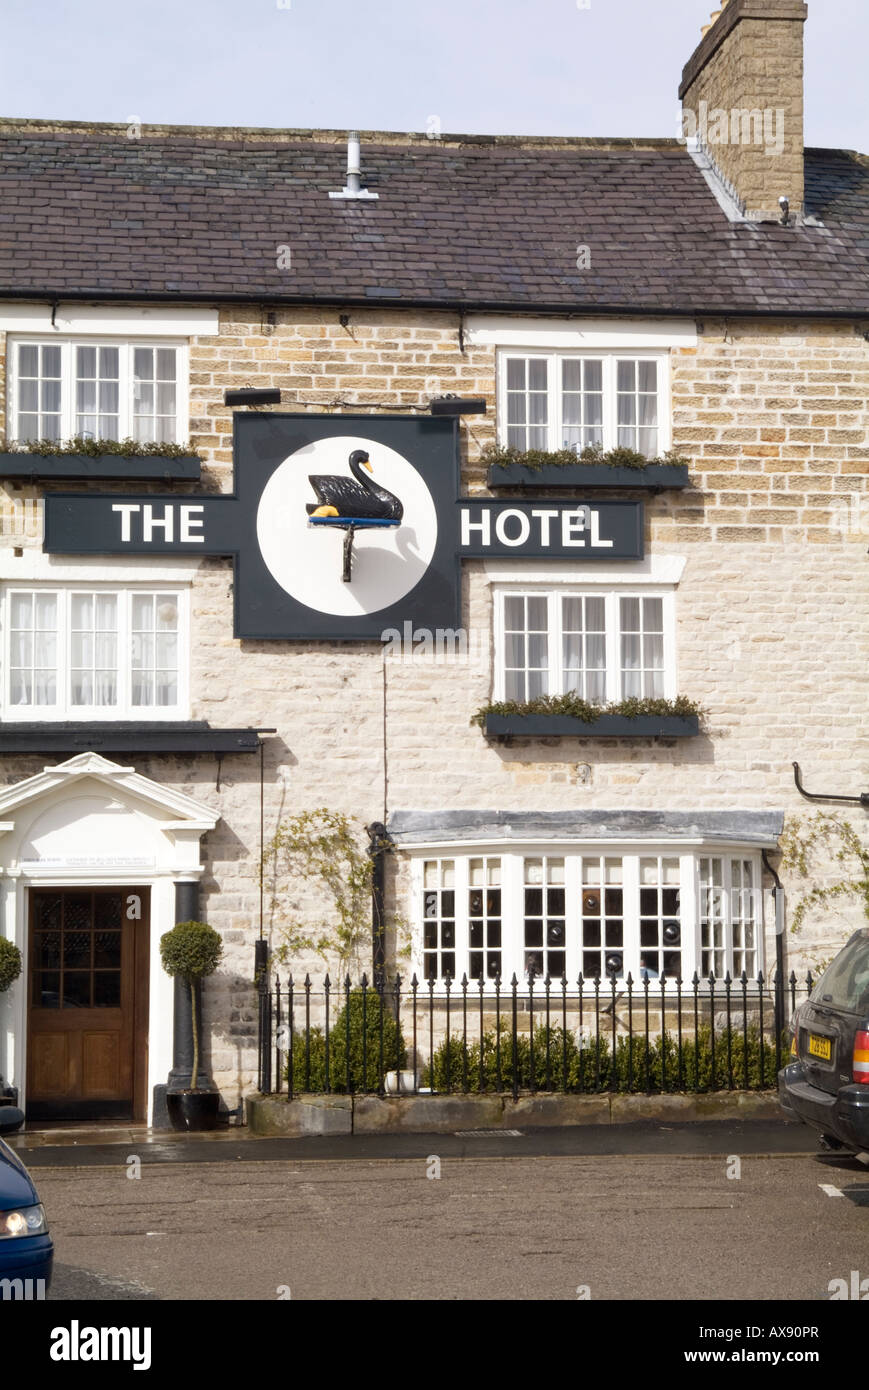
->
[256,435,438,617]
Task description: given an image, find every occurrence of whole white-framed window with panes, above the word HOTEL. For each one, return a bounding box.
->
[498,350,670,459]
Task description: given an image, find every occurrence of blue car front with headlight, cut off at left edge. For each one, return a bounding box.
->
[0,1105,54,1302]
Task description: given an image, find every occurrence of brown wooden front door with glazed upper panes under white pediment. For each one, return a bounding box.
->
[26,887,149,1120]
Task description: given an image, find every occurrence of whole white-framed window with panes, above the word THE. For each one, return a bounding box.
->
[8,338,188,443]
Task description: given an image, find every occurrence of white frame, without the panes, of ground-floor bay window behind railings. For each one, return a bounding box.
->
[409,841,766,998]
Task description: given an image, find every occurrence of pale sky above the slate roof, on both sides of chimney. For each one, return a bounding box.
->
[0,0,869,152]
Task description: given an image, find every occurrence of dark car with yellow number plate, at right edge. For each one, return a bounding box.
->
[779,927,869,1154]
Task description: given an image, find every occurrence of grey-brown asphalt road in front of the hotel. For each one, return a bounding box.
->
[25,1123,869,1301]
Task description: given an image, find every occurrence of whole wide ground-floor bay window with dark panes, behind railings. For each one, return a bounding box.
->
[412,845,763,990]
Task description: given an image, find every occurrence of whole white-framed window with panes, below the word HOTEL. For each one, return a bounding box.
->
[495,587,676,705]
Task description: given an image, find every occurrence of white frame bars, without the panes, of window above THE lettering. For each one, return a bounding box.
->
[7,334,190,443]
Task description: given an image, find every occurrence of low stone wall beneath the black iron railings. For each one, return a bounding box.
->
[247,1091,783,1138]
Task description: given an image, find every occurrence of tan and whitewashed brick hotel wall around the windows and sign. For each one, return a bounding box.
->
[1,310,869,1102]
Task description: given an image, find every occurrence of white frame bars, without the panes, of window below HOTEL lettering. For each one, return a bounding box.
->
[492,581,679,702]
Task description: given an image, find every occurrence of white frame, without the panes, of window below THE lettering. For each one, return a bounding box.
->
[0,578,190,724]
